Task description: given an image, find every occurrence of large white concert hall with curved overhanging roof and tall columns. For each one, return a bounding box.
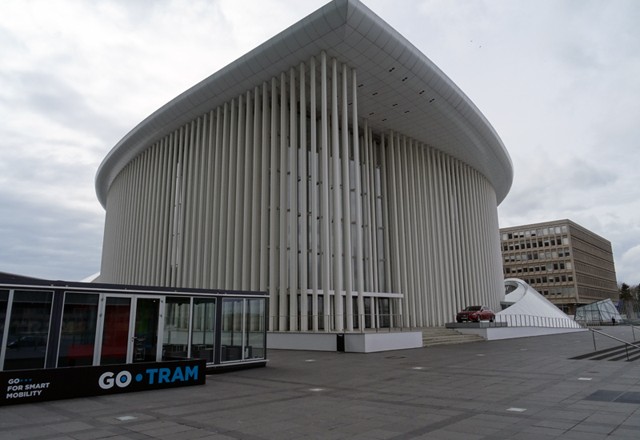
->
[96,0,513,332]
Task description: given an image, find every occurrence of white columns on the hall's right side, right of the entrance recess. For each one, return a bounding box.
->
[383,133,503,327]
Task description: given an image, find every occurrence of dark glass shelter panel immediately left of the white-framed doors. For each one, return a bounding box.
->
[58,292,100,367]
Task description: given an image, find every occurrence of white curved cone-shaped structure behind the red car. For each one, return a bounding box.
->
[496,278,580,328]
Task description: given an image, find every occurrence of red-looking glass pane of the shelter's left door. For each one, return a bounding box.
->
[100,296,131,365]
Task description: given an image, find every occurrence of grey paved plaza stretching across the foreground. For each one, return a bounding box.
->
[0,326,640,440]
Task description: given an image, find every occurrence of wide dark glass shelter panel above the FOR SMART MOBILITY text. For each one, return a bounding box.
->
[4,291,53,370]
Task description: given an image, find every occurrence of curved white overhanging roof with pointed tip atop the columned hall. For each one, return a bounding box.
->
[96,0,513,206]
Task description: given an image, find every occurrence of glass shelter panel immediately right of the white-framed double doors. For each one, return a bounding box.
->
[162,297,191,361]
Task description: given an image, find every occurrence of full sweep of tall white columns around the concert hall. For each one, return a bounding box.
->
[101,53,502,331]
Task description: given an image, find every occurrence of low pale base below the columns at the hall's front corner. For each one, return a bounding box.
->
[267,331,422,353]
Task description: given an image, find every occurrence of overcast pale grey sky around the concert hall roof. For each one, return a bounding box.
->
[0,0,640,284]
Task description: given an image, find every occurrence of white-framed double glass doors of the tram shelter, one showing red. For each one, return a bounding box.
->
[94,295,164,365]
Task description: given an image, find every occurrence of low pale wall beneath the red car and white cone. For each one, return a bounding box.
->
[446,322,586,341]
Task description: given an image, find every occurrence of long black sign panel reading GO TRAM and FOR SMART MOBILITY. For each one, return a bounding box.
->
[0,359,206,405]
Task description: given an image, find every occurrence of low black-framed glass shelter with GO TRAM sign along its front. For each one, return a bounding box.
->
[0,273,268,404]
